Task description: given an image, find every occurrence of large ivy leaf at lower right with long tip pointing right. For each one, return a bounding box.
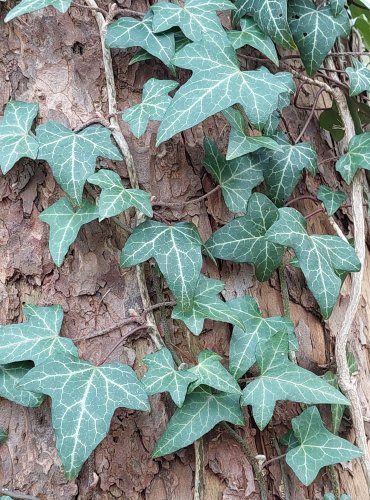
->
[241,332,349,430]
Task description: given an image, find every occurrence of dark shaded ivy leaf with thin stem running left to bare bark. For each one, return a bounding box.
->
[203,137,263,212]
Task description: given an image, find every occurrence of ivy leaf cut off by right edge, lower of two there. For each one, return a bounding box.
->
[336,132,370,184]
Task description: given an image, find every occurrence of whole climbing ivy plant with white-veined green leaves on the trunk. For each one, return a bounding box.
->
[0,0,370,497]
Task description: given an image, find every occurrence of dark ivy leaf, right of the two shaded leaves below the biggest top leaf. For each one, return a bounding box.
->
[259,134,317,206]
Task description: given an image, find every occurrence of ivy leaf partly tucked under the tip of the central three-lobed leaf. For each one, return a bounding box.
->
[172,274,243,335]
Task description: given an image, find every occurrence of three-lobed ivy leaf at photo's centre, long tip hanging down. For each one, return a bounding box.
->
[121,221,202,308]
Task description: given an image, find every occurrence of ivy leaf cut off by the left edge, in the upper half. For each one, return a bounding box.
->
[0,101,39,174]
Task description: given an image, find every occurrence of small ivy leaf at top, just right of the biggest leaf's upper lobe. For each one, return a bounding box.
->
[227,18,279,65]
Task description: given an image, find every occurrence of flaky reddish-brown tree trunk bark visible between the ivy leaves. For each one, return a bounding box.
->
[0,0,370,500]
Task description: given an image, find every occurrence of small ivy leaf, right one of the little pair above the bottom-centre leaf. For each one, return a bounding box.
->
[189,351,242,395]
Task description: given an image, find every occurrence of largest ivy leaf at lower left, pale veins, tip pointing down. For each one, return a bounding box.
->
[21,356,150,479]
